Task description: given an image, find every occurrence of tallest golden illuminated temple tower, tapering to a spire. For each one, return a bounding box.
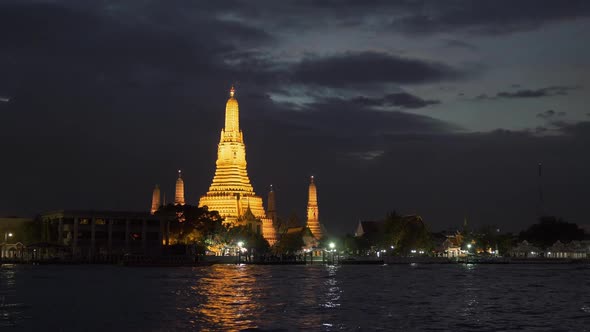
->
[199,87,266,223]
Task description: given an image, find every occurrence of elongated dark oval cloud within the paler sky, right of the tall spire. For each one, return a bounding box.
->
[291,52,465,87]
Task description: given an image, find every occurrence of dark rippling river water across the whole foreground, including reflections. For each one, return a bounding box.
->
[0,264,590,331]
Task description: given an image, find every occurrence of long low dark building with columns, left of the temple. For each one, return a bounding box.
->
[40,210,165,260]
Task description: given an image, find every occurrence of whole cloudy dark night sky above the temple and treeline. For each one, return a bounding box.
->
[0,0,590,234]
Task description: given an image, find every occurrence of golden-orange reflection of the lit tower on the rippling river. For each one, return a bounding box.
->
[187,265,261,331]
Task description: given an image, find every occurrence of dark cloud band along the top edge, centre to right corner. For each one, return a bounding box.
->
[170,0,590,35]
